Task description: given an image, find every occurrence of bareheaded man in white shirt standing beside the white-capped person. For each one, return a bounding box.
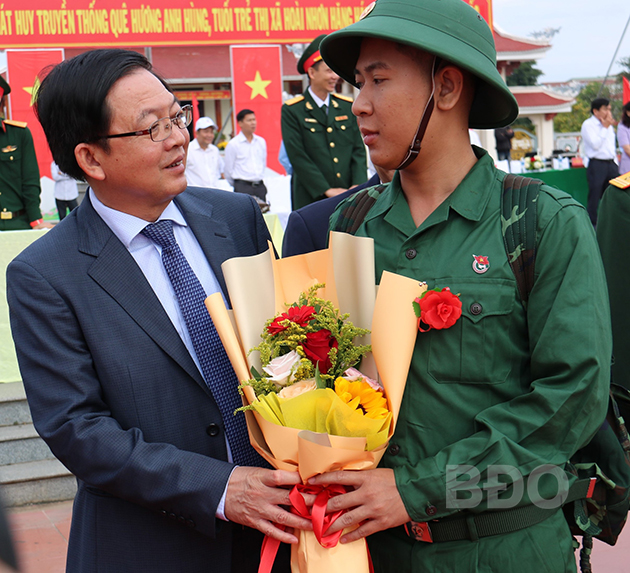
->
[223,109,267,202]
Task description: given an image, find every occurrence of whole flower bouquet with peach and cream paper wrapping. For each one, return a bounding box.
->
[206,233,426,573]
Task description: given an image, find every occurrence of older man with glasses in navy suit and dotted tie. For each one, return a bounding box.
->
[8,50,308,573]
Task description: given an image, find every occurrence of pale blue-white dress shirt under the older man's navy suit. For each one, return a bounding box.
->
[89,189,232,520]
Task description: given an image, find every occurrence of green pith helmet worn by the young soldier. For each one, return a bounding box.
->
[320,0,518,129]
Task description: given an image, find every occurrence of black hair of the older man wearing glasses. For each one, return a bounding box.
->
[33,49,171,181]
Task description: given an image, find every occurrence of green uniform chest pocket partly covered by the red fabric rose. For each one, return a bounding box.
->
[428,279,520,384]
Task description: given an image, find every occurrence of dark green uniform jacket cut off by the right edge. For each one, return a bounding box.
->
[597,186,630,390]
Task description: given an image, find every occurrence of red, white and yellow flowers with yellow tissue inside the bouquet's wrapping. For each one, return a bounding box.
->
[243,284,392,456]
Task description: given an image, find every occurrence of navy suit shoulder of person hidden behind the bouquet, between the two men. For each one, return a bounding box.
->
[282,173,381,257]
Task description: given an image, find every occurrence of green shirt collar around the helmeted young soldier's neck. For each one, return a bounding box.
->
[366,148,498,235]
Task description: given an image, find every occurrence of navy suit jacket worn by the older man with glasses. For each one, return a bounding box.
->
[7,188,269,573]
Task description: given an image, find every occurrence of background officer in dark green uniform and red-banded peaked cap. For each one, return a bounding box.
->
[282,35,367,209]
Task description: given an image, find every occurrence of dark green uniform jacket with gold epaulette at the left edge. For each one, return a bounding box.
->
[0,121,42,231]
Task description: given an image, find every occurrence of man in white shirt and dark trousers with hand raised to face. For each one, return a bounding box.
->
[582,98,619,226]
